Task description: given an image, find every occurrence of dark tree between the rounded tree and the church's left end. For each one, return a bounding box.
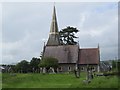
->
[30,57,40,72]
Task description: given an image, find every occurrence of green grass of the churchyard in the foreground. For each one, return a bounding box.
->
[2,73,118,88]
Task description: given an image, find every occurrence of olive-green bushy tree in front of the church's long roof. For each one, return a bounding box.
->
[39,57,58,71]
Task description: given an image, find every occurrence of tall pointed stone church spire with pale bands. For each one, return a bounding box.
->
[46,6,60,46]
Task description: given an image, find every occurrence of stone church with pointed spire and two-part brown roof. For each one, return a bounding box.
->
[43,6,100,72]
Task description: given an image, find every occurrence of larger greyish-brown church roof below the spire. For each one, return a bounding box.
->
[44,45,79,63]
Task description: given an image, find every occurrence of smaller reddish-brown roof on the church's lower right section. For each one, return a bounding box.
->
[78,48,99,64]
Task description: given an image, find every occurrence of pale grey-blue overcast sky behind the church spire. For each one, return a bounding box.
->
[0,2,118,64]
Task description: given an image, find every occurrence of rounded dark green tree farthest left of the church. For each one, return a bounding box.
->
[16,60,30,73]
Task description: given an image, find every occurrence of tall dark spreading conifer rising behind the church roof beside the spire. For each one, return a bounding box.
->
[59,26,79,45]
